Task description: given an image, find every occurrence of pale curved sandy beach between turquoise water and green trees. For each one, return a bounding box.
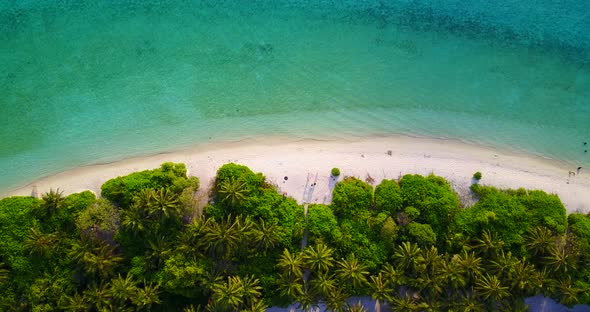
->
[4,137,590,212]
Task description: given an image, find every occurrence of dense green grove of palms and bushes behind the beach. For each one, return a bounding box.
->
[0,163,590,311]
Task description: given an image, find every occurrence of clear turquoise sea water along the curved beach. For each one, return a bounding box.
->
[0,0,590,190]
